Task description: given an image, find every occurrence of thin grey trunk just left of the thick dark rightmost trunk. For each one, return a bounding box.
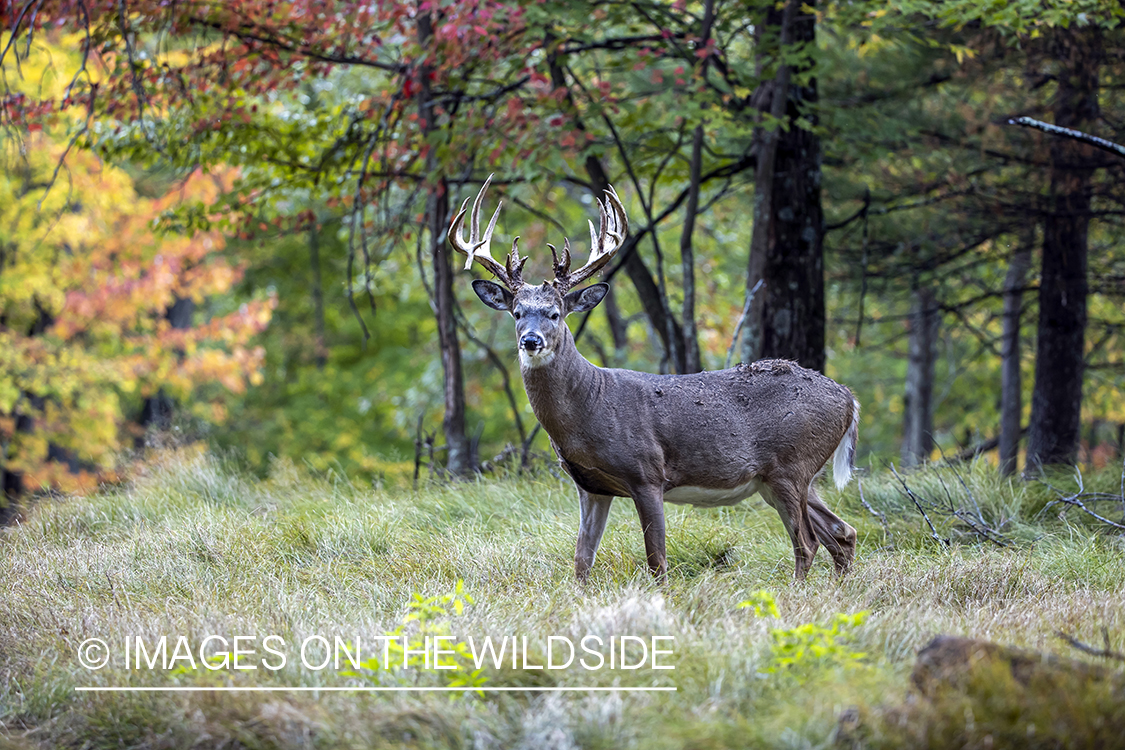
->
[1000,231,1035,477]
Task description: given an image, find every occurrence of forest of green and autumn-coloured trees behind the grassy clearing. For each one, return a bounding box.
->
[0,0,1125,515]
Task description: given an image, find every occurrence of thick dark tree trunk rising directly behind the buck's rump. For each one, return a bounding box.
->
[743,0,825,370]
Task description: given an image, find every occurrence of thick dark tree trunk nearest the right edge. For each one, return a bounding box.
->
[1027,28,1103,470]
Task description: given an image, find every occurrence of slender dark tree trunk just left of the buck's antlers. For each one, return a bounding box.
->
[419,13,476,477]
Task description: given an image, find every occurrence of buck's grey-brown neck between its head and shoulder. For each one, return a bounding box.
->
[520,326,604,442]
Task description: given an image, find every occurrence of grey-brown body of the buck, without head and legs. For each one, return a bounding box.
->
[523,340,853,495]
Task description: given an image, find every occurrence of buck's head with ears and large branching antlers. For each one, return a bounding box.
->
[449,175,629,369]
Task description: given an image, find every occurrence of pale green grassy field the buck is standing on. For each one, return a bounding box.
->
[0,453,1125,749]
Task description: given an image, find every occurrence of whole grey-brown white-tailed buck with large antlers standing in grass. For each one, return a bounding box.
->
[449,178,860,579]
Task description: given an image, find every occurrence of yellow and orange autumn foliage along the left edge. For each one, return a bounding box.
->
[0,36,273,499]
